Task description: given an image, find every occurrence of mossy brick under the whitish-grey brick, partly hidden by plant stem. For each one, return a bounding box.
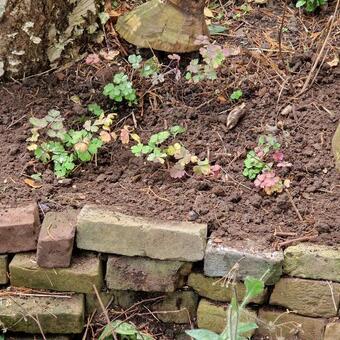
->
[188,273,268,304]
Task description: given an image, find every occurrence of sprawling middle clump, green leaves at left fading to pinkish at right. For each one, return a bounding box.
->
[131,125,220,178]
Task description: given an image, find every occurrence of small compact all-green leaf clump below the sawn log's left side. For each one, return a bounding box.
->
[103,72,137,106]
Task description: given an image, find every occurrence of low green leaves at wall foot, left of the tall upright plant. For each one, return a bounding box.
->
[98,320,154,340]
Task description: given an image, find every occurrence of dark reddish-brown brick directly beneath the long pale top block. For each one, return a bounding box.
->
[106,256,192,292]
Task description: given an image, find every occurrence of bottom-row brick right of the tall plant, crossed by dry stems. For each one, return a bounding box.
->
[256,309,326,340]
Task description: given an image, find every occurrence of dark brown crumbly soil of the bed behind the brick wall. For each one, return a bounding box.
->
[0,4,340,252]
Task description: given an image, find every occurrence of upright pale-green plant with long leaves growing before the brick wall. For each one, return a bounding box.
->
[186,277,264,340]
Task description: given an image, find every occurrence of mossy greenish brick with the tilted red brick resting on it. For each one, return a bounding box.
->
[9,253,103,293]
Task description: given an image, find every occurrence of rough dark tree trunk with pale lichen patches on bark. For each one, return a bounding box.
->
[0,0,97,79]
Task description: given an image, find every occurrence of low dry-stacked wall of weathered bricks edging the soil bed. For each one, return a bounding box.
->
[0,203,340,340]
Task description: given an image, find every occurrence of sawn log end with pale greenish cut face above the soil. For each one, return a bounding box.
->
[116,0,209,53]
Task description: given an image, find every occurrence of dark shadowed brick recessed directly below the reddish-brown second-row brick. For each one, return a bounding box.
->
[152,290,198,324]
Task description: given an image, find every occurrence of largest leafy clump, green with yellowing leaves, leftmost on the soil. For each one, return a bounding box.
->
[27,103,116,178]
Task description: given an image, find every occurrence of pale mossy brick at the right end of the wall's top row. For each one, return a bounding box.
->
[283,243,340,282]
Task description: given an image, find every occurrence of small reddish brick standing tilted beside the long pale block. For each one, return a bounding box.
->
[37,210,77,268]
